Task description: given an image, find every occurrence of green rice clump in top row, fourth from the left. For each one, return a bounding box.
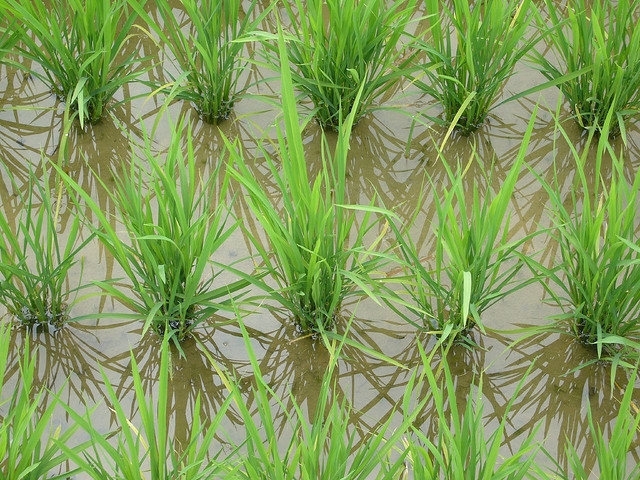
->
[414,0,542,135]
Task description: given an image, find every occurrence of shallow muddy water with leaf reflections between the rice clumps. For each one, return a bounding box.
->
[0,2,640,478]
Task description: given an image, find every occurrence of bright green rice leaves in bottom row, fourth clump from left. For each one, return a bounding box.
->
[408,347,548,480]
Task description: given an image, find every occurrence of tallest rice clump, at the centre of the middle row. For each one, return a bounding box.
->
[226,25,398,333]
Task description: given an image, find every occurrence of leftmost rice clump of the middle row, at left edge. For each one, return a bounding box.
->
[0,162,92,329]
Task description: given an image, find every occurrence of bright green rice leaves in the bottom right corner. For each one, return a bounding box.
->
[562,367,640,480]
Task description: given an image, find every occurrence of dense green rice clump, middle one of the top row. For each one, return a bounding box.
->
[285,0,416,131]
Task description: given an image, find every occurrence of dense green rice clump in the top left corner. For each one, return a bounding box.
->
[0,0,148,128]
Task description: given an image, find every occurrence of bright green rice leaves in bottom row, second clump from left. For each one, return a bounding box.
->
[60,335,232,480]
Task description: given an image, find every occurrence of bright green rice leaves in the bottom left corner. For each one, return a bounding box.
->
[0,322,87,480]
